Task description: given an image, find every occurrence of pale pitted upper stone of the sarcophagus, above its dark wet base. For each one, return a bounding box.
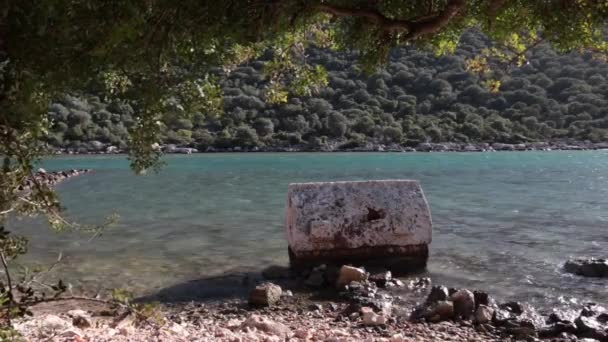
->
[285,180,432,256]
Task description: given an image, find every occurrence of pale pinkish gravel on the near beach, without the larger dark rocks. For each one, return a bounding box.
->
[15,300,504,342]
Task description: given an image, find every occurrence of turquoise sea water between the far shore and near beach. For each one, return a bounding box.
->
[5,151,608,305]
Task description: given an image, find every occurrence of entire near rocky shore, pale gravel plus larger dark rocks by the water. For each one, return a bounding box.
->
[16,265,608,342]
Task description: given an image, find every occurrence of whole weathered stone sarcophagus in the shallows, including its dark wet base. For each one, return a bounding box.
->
[285,180,432,273]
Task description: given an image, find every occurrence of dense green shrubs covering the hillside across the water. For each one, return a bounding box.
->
[49,32,608,152]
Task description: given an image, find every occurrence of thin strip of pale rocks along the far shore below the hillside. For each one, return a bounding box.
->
[54,140,608,155]
